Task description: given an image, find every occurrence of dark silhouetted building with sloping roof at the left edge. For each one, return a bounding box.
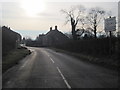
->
[2,26,21,56]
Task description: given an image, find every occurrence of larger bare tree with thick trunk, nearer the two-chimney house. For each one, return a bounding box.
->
[61,5,85,40]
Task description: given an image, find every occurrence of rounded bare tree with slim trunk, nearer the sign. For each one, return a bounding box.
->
[87,7,105,38]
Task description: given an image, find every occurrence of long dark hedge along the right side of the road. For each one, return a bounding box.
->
[54,37,120,59]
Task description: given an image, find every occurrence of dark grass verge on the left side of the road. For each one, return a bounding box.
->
[2,47,31,73]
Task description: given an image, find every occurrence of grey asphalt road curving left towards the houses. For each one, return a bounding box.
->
[3,47,118,89]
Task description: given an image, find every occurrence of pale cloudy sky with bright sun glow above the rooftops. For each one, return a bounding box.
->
[0,0,118,39]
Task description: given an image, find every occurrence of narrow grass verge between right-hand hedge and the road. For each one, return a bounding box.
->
[51,48,118,70]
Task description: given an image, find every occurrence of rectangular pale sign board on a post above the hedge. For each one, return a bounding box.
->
[104,17,116,32]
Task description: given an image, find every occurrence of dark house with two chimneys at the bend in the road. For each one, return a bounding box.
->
[37,26,68,46]
